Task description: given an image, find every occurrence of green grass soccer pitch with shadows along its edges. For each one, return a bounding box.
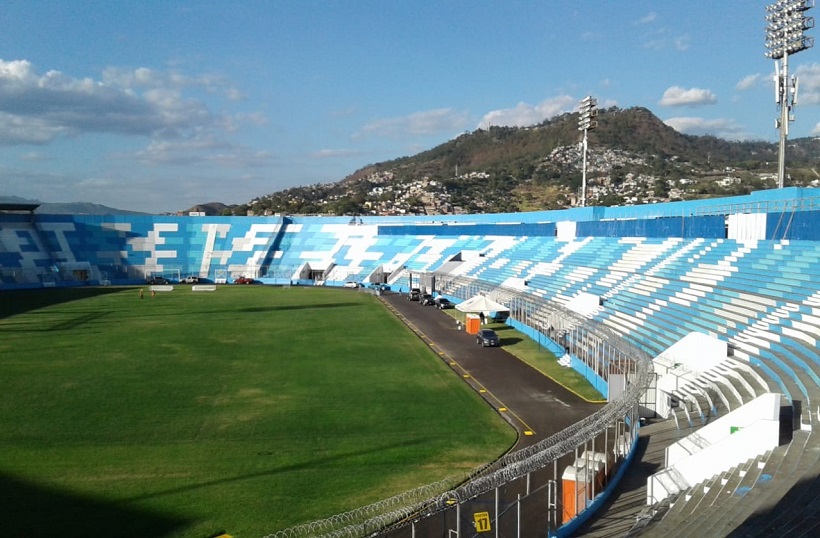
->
[0,286,515,538]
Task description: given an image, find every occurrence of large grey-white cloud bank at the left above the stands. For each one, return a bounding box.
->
[0,60,245,144]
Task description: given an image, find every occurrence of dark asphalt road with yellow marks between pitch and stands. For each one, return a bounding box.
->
[381,292,601,449]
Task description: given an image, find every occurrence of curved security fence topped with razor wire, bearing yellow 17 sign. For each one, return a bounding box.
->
[269,274,651,538]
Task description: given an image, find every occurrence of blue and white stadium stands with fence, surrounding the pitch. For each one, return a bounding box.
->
[0,188,820,536]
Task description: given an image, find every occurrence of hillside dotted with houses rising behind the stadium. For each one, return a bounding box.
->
[231,107,820,215]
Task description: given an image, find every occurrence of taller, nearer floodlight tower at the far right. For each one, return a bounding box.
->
[766,0,814,189]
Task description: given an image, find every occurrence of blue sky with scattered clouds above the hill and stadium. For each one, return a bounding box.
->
[0,0,820,213]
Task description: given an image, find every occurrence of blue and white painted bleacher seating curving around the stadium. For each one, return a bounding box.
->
[0,204,820,536]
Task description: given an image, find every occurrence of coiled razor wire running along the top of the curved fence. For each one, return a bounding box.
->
[265,274,652,538]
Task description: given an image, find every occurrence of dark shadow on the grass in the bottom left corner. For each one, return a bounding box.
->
[0,473,192,538]
